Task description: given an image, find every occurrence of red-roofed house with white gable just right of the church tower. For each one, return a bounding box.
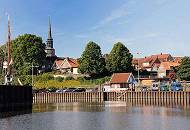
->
[54,57,79,74]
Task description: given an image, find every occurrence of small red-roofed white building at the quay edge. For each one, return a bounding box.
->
[107,73,136,92]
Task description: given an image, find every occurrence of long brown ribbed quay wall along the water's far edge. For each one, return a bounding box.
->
[33,91,190,104]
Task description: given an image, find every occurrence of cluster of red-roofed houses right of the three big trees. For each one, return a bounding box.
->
[132,53,183,78]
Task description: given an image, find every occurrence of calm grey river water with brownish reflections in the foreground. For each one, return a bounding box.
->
[0,102,190,130]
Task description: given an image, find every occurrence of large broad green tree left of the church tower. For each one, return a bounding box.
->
[12,34,46,74]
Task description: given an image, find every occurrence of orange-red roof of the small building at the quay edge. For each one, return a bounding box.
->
[110,73,132,84]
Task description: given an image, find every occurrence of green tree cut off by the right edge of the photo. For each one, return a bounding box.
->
[177,57,190,81]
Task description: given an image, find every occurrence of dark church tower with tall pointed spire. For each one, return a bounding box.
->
[45,19,55,57]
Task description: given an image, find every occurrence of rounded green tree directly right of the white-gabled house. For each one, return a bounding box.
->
[79,41,105,76]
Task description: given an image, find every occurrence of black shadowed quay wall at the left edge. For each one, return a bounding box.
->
[0,85,33,117]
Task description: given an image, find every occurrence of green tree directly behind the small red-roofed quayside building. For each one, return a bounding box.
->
[106,42,133,73]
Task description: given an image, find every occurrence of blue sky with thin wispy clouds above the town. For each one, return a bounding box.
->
[0,0,190,57]
